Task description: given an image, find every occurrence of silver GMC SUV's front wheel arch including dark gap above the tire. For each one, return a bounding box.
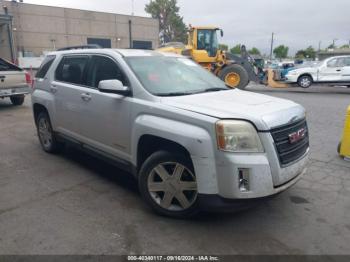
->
[131,115,218,194]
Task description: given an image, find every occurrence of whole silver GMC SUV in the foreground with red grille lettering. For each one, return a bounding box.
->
[32,49,309,217]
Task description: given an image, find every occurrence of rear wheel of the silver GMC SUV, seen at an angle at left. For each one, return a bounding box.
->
[36,112,61,153]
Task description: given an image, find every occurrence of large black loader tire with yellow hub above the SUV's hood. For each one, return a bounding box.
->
[218,64,249,89]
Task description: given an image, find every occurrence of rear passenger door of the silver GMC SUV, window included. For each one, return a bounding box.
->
[49,55,90,140]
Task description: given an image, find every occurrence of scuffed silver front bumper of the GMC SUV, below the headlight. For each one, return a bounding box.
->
[192,147,308,200]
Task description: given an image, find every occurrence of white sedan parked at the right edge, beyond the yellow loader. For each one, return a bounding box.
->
[285,56,350,88]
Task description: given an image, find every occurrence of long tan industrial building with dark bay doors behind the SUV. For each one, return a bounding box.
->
[0,1,159,68]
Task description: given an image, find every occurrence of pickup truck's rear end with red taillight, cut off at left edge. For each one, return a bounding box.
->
[0,58,31,106]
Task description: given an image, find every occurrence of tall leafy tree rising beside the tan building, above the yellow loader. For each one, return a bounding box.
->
[145,0,187,43]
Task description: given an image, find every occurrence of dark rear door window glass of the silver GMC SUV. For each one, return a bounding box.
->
[56,56,89,85]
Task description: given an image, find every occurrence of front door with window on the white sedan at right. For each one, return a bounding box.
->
[318,58,342,82]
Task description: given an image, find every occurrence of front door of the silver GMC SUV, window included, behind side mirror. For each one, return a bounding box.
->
[81,55,132,160]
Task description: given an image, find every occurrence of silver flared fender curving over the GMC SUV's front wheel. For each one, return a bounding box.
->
[131,115,218,194]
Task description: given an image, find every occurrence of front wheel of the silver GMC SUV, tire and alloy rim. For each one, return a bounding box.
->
[139,151,199,218]
